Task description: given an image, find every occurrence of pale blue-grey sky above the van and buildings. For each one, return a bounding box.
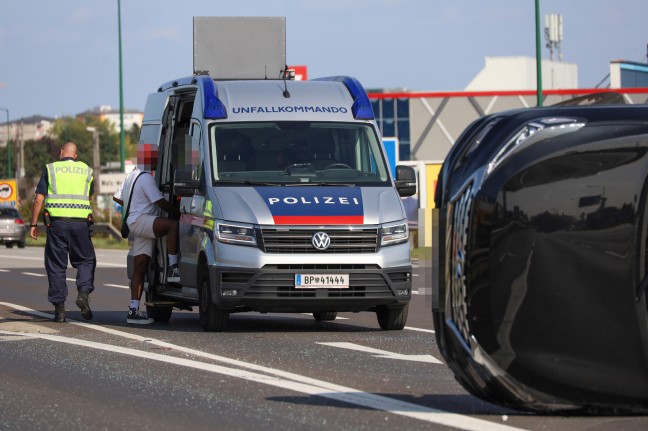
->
[0,0,648,122]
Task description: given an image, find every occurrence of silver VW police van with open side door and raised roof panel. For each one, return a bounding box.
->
[135,17,416,331]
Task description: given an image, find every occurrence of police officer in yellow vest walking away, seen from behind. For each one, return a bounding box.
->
[30,142,97,322]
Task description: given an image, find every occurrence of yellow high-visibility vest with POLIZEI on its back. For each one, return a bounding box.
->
[45,160,92,218]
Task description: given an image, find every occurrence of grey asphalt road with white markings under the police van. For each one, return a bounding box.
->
[0,247,648,431]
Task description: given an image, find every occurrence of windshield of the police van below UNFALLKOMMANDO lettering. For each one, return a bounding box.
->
[210,121,389,186]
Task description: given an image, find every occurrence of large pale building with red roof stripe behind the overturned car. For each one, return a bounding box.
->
[369,57,648,163]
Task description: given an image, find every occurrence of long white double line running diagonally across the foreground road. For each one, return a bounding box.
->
[0,302,522,431]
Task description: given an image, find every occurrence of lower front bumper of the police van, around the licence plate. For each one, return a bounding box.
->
[210,264,412,313]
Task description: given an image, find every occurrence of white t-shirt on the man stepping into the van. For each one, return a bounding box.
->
[113,168,164,224]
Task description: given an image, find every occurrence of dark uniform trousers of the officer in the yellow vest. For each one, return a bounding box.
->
[45,218,97,304]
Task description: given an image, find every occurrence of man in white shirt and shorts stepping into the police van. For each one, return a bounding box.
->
[113,143,180,325]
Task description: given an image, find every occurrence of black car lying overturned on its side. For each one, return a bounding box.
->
[432,101,648,414]
